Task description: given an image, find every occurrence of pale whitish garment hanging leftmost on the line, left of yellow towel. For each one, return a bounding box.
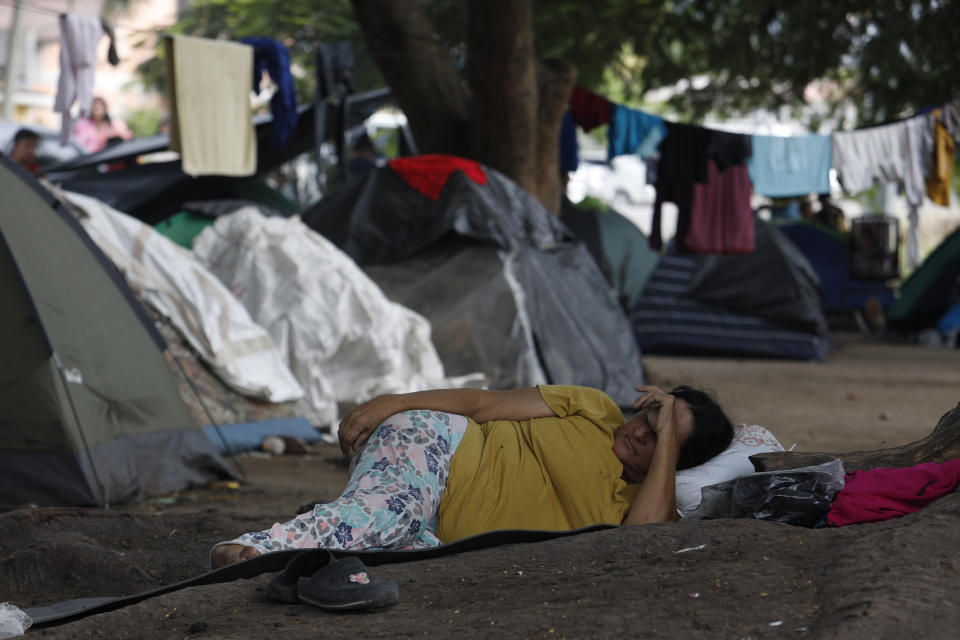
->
[53,13,120,144]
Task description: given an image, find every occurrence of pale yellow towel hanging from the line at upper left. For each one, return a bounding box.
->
[164,36,257,176]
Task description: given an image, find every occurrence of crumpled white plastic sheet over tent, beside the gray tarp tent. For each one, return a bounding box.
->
[194,207,483,422]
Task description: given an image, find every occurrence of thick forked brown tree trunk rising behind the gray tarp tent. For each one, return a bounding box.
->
[352,0,575,214]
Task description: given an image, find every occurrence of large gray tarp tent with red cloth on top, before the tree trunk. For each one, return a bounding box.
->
[301,160,643,406]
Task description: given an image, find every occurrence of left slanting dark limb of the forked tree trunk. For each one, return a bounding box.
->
[352,0,472,157]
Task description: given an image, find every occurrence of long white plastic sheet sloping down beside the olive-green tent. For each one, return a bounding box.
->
[61,192,304,402]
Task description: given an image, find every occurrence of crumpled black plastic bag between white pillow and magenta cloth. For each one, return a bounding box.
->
[687,460,844,527]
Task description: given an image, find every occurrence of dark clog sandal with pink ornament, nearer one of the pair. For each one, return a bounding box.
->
[297,558,400,611]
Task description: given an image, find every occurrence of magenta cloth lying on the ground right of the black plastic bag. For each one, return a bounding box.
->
[827,460,960,527]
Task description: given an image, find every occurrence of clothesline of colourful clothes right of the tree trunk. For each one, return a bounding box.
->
[561,87,960,266]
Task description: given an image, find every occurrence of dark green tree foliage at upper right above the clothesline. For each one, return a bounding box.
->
[532,0,960,130]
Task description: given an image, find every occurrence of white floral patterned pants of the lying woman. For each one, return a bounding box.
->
[216,410,468,553]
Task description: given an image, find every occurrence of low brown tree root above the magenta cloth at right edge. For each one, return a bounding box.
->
[750,404,960,471]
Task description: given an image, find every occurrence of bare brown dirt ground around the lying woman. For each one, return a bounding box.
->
[0,334,960,638]
